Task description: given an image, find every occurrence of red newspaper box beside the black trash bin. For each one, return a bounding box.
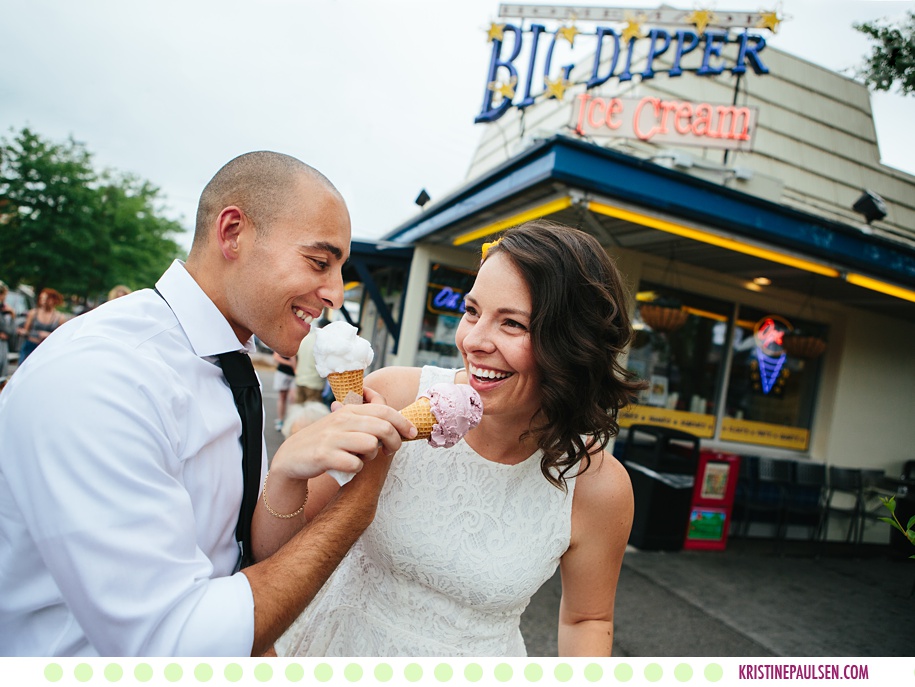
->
[683,451,740,551]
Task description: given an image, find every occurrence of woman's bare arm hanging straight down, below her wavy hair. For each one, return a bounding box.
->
[559,452,633,656]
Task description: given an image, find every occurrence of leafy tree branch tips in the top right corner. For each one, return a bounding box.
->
[852,12,915,95]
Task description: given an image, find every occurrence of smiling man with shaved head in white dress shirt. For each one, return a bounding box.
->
[0,152,415,656]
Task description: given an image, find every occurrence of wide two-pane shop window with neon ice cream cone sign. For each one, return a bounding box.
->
[620,282,828,450]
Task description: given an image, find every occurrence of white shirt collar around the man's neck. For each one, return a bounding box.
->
[156,260,254,358]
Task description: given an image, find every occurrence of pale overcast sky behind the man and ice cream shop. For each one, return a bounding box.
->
[0,0,915,245]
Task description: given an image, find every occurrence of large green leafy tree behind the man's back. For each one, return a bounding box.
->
[0,128,182,299]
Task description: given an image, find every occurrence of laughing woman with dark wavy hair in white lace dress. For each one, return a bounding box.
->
[277,221,640,656]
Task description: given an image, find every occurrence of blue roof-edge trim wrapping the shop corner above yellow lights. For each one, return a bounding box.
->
[386,136,915,286]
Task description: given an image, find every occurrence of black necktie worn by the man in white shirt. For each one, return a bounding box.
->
[216,351,264,568]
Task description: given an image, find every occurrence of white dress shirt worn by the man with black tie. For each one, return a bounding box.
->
[0,261,266,656]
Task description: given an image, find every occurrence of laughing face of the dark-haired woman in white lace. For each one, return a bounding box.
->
[455,253,540,422]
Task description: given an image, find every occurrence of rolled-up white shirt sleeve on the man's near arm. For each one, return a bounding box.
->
[5,339,254,656]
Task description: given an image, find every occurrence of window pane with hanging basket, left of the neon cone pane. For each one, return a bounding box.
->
[621,283,733,437]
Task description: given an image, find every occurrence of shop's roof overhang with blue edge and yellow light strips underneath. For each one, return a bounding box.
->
[384,135,915,320]
